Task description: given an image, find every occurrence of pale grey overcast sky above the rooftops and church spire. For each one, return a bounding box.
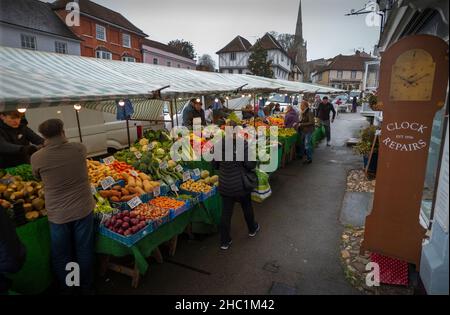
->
[56,0,379,63]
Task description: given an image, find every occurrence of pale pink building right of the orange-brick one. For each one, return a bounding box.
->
[142,39,196,70]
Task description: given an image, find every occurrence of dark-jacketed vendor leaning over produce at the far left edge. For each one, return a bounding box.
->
[0,111,44,168]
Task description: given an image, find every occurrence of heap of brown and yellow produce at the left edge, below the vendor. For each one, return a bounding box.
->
[0,174,47,221]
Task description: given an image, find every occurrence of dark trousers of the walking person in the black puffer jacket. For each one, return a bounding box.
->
[220,193,256,244]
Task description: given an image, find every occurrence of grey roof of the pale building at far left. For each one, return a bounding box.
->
[0,0,80,40]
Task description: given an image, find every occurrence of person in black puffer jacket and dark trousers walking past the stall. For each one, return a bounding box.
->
[214,137,259,250]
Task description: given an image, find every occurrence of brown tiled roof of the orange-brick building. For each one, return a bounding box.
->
[52,0,147,37]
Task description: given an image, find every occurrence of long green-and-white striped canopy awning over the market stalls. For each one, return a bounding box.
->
[0,47,340,112]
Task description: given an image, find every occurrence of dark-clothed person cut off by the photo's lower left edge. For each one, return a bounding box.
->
[0,207,26,295]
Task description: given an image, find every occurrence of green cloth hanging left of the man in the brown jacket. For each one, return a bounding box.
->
[9,217,52,294]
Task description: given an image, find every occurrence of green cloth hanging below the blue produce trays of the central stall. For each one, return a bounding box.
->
[96,194,222,274]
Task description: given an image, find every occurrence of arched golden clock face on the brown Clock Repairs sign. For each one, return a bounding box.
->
[390,49,436,101]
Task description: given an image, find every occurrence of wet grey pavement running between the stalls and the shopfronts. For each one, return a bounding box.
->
[97,113,367,295]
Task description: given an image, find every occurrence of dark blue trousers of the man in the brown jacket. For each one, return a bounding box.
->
[50,213,94,293]
